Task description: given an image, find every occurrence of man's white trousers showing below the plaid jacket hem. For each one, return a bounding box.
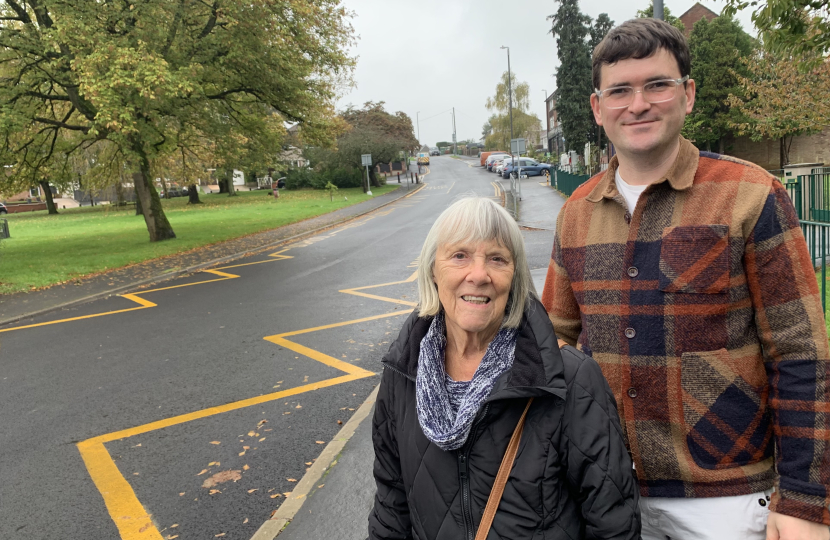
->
[640,489,772,540]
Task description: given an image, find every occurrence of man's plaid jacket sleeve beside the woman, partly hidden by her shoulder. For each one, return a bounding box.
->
[542,207,582,346]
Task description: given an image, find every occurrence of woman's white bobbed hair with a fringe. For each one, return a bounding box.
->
[418,197,537,328]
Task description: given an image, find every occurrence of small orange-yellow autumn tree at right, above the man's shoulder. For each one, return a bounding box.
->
[729,50,830,167]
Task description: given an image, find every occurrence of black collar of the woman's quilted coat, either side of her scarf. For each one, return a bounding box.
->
[382,298,567,401]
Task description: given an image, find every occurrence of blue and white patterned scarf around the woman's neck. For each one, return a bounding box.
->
[415,313,516,450]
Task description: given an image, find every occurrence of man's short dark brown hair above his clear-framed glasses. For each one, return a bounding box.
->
[591,19,692,89]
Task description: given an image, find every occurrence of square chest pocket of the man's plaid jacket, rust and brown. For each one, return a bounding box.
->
[658,225,729,294]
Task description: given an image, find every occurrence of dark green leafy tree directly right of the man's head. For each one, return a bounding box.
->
[683,16,754,154]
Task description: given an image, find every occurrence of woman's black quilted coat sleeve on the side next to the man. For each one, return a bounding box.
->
[562,347,640,540]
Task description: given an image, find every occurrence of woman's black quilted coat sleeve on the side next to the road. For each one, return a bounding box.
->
[369,369,412,540]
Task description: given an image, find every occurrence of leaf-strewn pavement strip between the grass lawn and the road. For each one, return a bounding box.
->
[0,179,419,326]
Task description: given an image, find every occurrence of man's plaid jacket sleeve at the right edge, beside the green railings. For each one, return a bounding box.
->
[744,180,830,525]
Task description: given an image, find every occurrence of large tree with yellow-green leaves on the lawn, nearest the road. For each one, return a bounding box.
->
[0,0,354,241]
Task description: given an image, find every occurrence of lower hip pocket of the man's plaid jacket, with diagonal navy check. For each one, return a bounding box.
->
[680,349,772,470]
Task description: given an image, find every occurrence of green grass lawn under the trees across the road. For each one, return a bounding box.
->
[0,185,398,294]
